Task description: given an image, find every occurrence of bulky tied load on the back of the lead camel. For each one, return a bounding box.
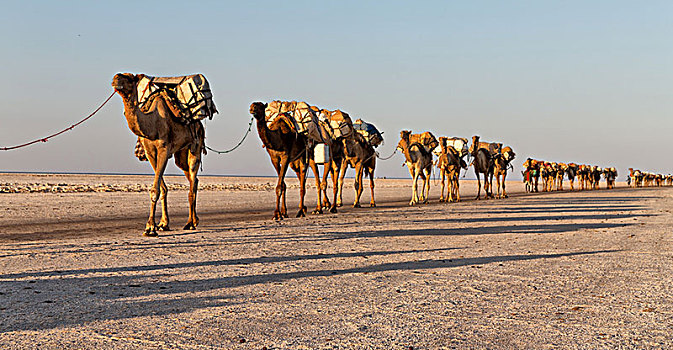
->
[138,74,217,124]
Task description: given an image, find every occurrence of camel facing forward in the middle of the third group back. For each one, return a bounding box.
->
[437,136,467,202]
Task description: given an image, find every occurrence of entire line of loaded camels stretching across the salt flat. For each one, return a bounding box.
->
[107,73,673,236]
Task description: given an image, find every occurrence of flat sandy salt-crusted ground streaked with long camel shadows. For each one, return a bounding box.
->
[0,174,673,349]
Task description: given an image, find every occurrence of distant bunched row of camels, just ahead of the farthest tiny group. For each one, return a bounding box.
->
[521,158,617,192]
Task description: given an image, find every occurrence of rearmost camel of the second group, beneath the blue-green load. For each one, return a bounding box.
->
[337,132,376,208]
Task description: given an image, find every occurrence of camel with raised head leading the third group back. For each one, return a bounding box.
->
[397,130,432,205]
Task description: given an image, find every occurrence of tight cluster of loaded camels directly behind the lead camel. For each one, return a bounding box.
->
[250,101,383,220]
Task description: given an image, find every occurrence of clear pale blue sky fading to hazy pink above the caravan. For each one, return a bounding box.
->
[0,0,673,179]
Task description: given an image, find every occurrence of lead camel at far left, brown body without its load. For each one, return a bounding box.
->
[112,73,205,236]
